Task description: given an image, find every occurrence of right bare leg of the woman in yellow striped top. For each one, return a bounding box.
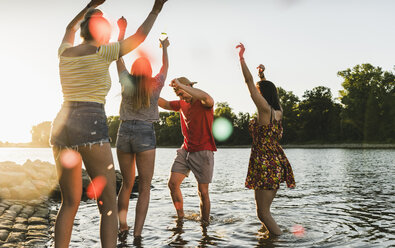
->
[79,143,118,248]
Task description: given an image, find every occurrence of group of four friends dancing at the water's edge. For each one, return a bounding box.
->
[50,0,295,247]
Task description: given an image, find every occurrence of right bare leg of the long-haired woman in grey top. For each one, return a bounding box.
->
[133,149,155,237]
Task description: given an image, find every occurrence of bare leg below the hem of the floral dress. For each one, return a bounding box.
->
[255,190,282,235]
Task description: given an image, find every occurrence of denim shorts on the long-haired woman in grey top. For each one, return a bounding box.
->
[116,120,156,153]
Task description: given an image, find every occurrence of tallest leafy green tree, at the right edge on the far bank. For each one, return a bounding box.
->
[338,64,395,142]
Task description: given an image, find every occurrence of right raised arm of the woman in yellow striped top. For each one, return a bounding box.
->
[119,0,167,57]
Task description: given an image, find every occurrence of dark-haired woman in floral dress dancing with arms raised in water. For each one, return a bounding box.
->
[236,43,295,235]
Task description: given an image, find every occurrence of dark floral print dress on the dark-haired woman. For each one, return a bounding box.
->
[245,119,295,190]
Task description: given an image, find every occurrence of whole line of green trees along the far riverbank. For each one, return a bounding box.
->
[31,64,395,146]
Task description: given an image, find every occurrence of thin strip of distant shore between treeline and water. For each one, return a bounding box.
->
[0,143,395,149]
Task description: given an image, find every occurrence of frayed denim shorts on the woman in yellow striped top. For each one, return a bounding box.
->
[50,102,110,148]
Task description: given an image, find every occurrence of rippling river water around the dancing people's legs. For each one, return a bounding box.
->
[0,148,395,247]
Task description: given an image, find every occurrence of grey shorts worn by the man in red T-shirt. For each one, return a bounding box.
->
[171,148,214,183]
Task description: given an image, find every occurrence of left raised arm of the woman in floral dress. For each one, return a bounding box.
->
[236,43,270,112]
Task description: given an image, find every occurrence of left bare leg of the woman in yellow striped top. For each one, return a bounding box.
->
[53,147,82,248]
